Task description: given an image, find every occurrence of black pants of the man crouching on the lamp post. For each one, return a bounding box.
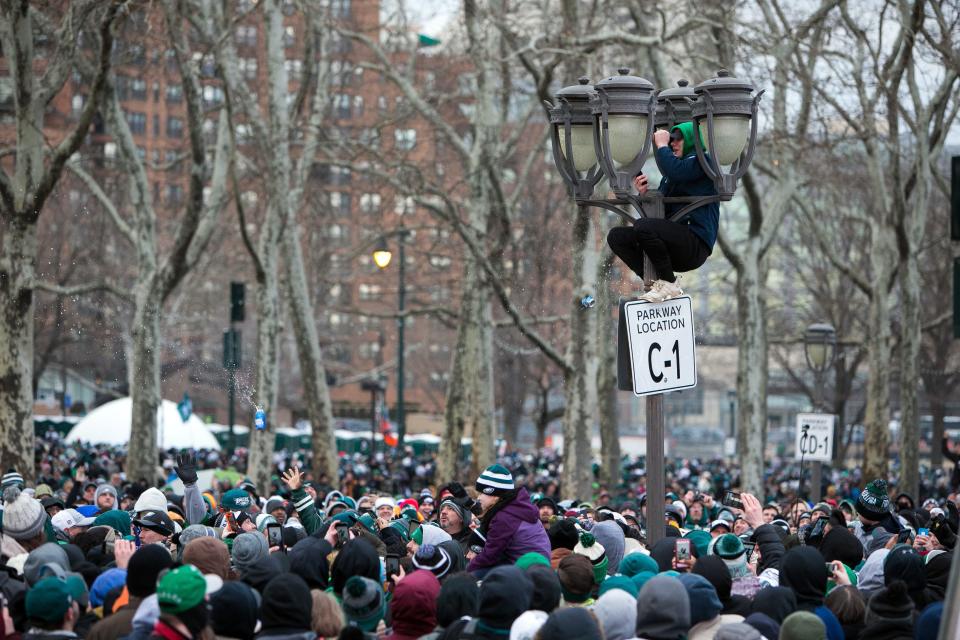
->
[607,218,710,282]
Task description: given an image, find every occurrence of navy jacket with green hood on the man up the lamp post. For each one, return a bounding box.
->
[656,122,720,252]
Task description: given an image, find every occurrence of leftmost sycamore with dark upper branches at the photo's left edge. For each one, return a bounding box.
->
[0,0,122,481]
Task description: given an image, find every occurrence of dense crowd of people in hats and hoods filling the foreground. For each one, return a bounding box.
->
[0,444,960,640]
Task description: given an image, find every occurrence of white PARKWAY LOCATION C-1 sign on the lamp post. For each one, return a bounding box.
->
[623,296,697,396]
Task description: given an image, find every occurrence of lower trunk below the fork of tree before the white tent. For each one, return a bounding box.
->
[127,290,162,487]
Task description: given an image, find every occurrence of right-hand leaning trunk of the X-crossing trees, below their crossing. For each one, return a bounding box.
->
[284,224,337,478]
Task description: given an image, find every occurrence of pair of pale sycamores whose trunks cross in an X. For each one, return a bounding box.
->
[212,0,337,487]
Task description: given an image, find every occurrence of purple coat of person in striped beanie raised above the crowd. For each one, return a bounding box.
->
[467,488,550,571]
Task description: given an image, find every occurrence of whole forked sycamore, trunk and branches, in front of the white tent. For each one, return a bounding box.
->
[69,0,232,486]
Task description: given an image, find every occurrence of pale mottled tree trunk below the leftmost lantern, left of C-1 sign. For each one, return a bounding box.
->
[560,207,597,499]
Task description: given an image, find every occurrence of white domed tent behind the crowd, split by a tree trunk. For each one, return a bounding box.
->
[67,398,220,450]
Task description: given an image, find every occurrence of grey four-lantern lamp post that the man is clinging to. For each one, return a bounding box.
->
[546,67,763,545]
